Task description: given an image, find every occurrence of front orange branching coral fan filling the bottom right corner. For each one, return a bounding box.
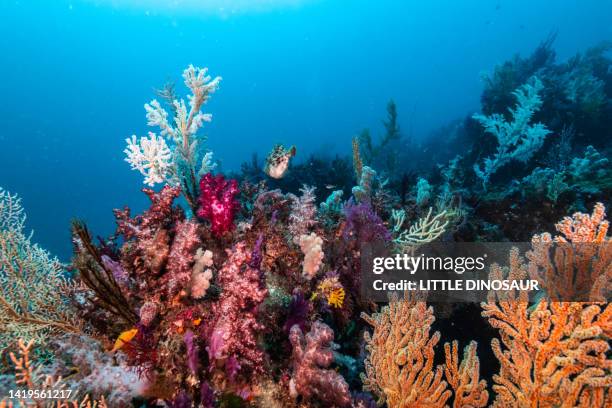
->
[482,245,612,407]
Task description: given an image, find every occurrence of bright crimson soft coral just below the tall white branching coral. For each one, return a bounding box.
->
[198,173,240,236]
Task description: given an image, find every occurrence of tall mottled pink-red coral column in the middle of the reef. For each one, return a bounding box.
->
[207,242,268,375]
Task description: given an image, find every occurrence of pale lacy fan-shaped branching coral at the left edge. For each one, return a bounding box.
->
[0,188,82,350]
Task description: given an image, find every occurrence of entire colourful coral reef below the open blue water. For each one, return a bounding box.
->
[0,47,612,408]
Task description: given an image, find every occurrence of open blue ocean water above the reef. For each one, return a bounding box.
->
[0,0,612,260]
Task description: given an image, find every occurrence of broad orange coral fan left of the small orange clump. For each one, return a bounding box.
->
[361,292,451,408]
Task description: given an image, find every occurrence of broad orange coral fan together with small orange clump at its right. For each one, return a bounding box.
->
[361,292,489,408]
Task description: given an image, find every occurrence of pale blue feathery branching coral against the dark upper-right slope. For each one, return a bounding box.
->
[473,77,550,188]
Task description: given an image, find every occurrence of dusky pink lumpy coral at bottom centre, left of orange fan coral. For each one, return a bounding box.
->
[289,321,351,407]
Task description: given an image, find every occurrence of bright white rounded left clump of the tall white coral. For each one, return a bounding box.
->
[123,132,174,186]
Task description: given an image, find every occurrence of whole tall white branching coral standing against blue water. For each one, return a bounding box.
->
[125,65,221,208]
